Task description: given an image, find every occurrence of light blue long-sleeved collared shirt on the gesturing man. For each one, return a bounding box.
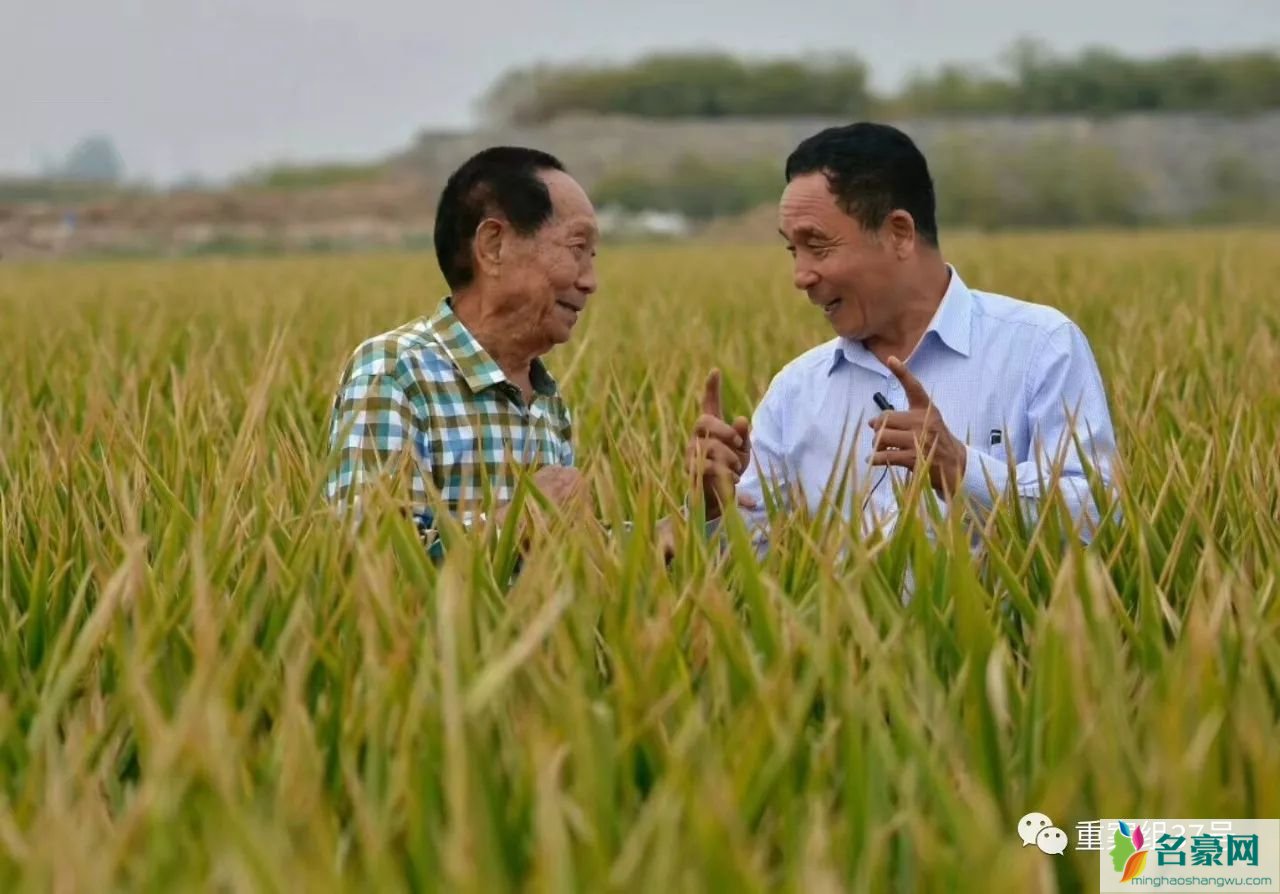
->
[739,265,1115,539]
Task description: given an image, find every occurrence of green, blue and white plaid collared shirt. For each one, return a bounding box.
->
[326,298,573,544]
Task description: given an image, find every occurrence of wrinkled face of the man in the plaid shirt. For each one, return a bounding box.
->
[502,170,599,350]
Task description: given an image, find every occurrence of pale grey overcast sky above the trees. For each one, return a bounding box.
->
[0,0,1280,181]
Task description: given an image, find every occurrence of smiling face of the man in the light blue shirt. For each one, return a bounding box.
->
[778,173,902,341]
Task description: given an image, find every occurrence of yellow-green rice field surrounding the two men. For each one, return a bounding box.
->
[0,232,1280,891]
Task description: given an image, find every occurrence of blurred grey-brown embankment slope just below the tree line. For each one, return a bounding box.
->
[393,111,1280,216]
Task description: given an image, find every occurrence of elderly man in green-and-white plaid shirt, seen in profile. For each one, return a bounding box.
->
[328,147,598,555]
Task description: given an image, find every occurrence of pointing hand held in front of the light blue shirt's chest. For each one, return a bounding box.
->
[868,357,966,497]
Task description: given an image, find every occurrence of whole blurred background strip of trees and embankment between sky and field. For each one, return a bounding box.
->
[0,40,1280,257]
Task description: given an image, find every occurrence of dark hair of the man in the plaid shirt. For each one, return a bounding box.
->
[435,146,564,291]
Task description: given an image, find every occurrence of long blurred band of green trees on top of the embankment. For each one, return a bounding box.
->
[481,41,1280,124]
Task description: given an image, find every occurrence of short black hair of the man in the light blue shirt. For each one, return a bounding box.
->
[786,122,938,246]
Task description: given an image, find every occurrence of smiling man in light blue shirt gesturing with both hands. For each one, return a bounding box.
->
[690,123,1115,539]
